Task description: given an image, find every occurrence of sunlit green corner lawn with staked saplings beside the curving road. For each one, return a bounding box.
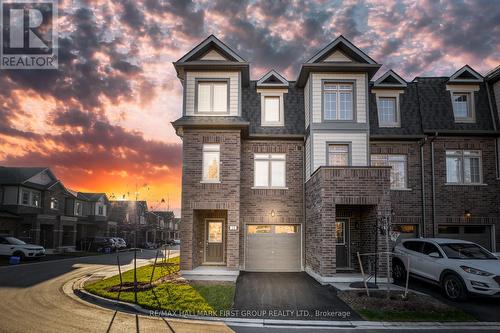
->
[85,257,234,315]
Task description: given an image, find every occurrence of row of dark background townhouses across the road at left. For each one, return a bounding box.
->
[0,166,177,251]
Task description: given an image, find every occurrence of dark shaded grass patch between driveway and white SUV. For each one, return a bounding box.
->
[338,290,474,322]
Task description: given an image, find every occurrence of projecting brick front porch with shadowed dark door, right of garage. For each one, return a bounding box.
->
[305,167,391,283]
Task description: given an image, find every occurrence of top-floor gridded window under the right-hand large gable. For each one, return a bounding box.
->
[323,82,354,121]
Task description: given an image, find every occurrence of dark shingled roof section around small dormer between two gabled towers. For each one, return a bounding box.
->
[241,81,305,135]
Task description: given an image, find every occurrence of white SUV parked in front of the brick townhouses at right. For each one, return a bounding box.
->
[392,238,500,301]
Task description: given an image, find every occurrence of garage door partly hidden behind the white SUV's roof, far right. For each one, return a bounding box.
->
[437,224,492,250]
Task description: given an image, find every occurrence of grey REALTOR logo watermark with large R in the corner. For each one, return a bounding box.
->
[0,0,58,69]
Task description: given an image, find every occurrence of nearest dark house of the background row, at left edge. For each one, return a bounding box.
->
[0,167,76,249]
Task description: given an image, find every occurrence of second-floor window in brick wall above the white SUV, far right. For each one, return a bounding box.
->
[446,150,482,184]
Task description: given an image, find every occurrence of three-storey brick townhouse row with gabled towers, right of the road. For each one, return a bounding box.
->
[172,35,500,282]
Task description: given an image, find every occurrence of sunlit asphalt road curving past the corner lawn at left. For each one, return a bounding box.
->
[0,250,231,333]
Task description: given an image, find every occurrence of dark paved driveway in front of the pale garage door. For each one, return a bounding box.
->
[233,272,361,320]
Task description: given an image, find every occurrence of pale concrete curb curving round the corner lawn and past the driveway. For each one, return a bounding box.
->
[68,277,500,331]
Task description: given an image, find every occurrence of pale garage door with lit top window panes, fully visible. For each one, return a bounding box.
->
[245,225,301,272]
